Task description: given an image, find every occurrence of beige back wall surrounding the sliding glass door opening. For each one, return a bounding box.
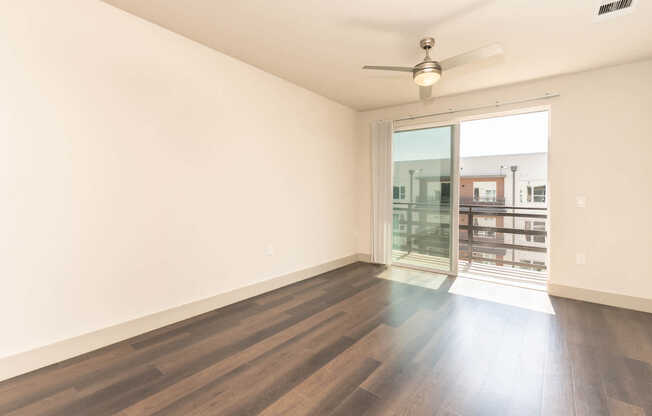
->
[356,60,652,298]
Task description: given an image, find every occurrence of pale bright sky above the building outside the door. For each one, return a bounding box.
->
[392,111,548,162]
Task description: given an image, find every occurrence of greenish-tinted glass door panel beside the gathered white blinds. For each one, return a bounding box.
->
[392,125,459,275]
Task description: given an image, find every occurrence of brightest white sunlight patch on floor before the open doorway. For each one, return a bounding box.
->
[448,277,555,315]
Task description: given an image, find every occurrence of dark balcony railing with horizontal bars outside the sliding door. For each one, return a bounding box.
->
[393,201,548,270]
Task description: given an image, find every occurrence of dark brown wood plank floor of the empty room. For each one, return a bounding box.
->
[0,264,652,416]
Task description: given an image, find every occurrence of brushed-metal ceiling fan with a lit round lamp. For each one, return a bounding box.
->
[362,38,503,100]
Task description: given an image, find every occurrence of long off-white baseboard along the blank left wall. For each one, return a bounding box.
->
[0,254,365,381]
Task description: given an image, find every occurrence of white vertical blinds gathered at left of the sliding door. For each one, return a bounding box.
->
[371,120,392,264]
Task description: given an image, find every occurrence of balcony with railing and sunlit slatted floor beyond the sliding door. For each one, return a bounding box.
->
[393,200,548,286]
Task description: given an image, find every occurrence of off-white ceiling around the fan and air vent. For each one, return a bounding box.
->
[105,0,652,110]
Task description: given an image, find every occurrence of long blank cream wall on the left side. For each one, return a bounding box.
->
[0,0,357,357]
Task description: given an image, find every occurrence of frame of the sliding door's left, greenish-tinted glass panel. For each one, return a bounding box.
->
[392,120,460,277]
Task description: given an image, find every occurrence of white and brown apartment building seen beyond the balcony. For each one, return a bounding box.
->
[393,153,547,269]
